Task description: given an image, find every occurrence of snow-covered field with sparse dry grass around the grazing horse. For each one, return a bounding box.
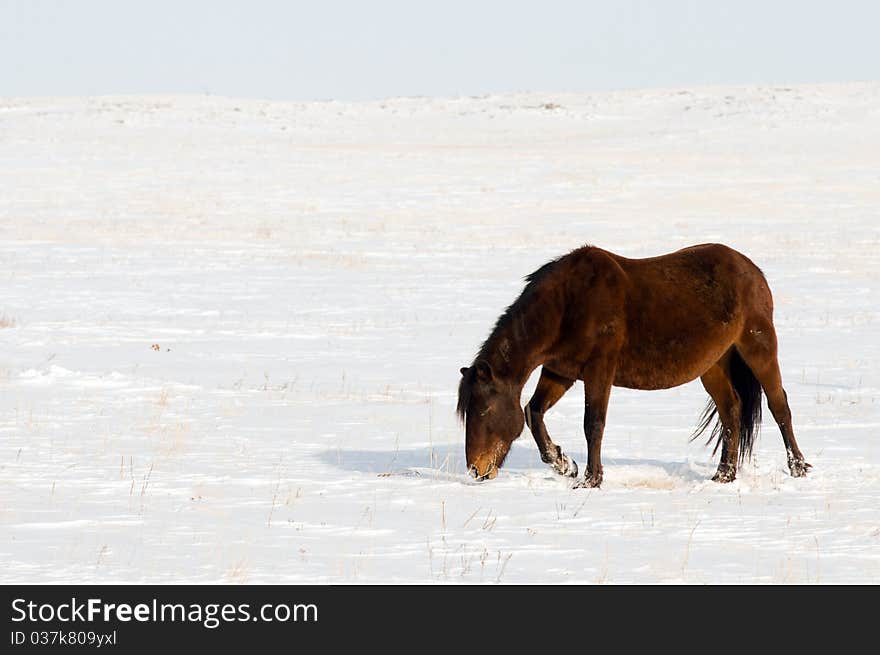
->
[0,84,880,584]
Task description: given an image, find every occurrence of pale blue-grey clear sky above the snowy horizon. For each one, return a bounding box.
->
[0,0,880,100]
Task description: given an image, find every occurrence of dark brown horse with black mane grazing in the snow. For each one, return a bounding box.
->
[458,244,810,487]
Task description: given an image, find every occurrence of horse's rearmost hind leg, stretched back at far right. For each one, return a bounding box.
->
[736,321,812,478]
